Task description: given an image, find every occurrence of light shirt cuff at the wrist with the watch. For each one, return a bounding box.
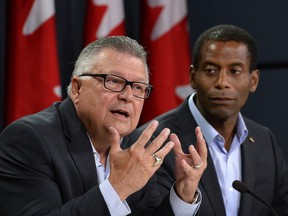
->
[169,183,202,216]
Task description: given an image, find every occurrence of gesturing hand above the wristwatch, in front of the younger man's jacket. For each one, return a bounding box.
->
[170,127,207,203]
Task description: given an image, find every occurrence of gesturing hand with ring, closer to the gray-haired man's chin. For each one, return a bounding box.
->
[109,121,173,200]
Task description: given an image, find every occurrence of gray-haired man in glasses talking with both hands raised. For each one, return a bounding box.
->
[0,36,206,216]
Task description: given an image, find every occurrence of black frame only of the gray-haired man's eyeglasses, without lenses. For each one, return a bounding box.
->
[78,73,153,99]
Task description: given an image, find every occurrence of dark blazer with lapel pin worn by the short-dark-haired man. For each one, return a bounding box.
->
[135,98,288,216]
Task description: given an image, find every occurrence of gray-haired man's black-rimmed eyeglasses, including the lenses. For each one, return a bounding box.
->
[80,73,153,99]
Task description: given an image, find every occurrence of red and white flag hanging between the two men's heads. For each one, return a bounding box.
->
[140,0,192,123]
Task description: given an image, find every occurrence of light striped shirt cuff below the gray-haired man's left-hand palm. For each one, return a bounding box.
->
[99,179,131,216]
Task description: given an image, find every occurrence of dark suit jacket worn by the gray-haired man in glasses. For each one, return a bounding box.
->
[0,98,173,216]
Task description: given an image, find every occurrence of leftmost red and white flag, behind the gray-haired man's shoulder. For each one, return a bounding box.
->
[5,0,61,124]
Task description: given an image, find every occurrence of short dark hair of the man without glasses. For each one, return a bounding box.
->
[193,24,258,71]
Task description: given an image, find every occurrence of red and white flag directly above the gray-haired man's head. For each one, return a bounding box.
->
[84,0,125,45]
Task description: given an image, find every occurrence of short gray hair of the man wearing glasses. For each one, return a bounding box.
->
[67,36,149,95]
